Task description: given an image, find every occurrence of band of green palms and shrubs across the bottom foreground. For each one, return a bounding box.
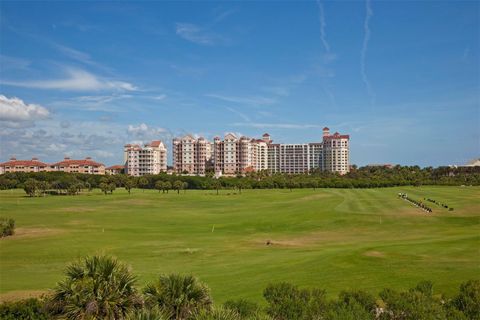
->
[0,256,480,320]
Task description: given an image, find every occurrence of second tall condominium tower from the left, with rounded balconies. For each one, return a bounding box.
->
[172,134,212,175]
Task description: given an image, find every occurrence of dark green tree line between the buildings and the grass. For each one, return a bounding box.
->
[0,166,480,196]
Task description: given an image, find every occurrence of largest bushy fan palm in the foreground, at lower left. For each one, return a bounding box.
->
[50,256,142,320]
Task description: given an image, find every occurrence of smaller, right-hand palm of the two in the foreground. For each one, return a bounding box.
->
[143,274,212,320]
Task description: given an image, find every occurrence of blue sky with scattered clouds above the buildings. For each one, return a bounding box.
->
[0,1,480,166]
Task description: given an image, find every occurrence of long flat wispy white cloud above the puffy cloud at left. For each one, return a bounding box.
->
[0,67,138,91]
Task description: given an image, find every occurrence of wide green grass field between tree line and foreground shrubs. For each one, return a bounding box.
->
[0,187,480,302]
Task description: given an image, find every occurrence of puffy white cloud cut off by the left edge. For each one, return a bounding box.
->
[0,95,50,122]
